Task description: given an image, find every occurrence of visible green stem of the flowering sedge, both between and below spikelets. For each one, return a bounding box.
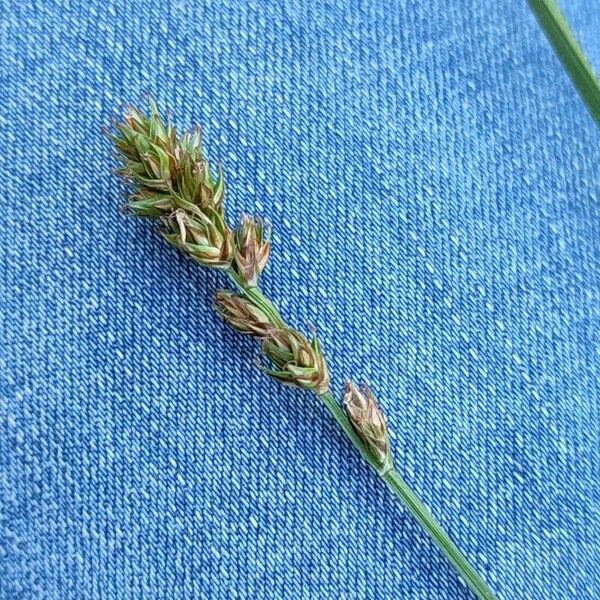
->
[227,278,495,600]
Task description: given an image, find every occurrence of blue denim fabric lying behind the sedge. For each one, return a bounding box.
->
[0,0,600,600]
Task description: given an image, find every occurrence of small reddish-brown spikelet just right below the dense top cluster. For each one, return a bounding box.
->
[234,215,271,286]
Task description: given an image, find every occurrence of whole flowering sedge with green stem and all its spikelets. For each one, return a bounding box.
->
[106,99,495,600]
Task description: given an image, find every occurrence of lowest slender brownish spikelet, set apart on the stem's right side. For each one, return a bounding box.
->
[344,380,392,469]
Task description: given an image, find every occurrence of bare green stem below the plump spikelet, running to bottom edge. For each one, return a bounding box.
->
[319,392,495,600]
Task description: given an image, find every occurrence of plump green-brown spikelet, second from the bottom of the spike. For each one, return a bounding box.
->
[261,327,329,394]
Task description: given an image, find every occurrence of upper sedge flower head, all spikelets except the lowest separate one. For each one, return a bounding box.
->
[107,99,329,393]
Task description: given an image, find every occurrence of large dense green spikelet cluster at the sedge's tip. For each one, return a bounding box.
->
[109,99,234,269]
